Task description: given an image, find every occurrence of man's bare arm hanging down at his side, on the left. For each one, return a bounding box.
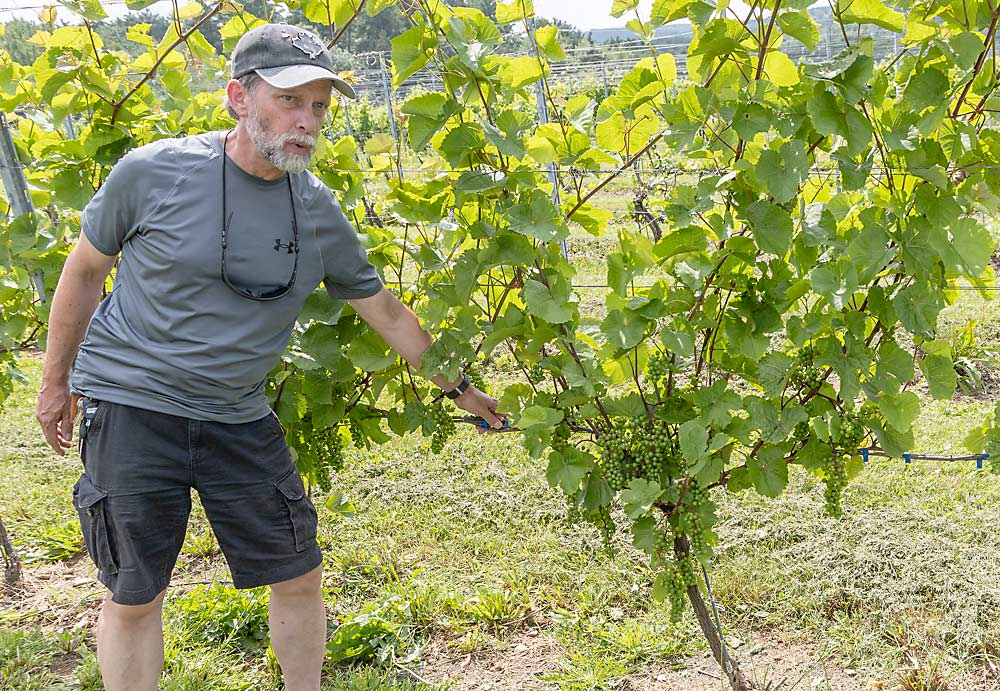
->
[35,233,115,456]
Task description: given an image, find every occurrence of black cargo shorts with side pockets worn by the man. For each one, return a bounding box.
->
[73,398,322,605]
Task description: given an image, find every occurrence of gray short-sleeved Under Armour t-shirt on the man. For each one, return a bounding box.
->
[71,132,382,423]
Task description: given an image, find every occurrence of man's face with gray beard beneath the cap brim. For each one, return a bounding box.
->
[246,80,331,173]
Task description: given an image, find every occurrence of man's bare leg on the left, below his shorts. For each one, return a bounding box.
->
[97,591,165,691]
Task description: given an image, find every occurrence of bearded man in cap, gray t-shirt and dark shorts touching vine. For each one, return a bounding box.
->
[37,24,502,691]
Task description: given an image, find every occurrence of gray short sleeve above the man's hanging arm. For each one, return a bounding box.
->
[80,150,144,256]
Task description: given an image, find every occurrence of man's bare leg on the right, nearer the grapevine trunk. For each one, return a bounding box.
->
[270,566,326,691]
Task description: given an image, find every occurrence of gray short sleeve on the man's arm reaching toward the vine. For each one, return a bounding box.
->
[316,187,382,300]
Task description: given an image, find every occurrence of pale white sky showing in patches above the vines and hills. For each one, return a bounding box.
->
[0,0,746,31]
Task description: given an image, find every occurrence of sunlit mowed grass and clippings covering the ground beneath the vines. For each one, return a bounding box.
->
[0,286,1000,691]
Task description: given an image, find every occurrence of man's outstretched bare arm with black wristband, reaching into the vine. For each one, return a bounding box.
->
[348,287,503,429]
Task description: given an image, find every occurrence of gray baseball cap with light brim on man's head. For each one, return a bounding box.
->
[233,24,357,98]
